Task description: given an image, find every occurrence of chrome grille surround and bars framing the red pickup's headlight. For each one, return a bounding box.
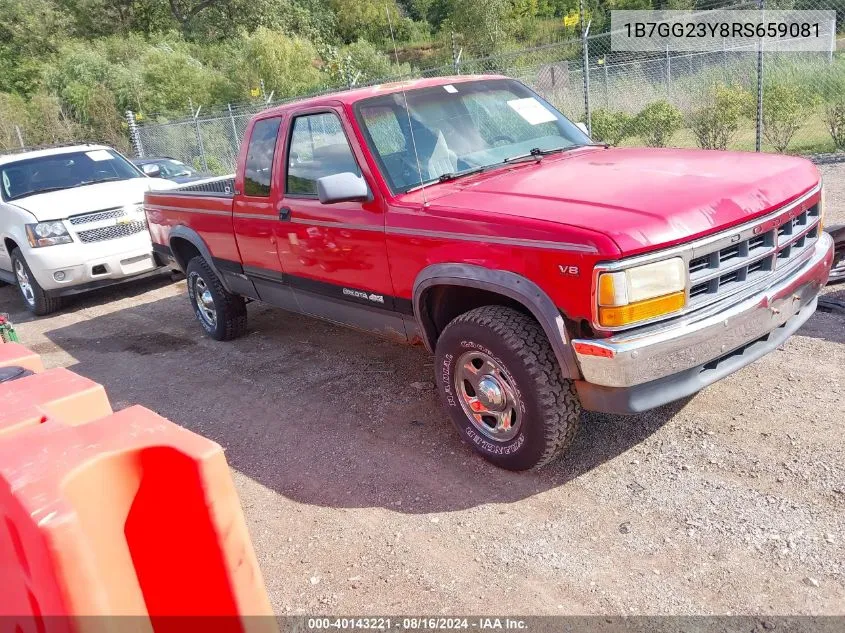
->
[591,182,822,332]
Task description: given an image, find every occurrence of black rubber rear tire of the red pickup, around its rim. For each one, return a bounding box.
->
[185,255,247,341]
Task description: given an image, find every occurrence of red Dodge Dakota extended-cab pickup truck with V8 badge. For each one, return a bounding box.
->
[145,76,833,470]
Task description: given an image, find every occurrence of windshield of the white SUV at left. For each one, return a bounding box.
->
[0,149,144,200]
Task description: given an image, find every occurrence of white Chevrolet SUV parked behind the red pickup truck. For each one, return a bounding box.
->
[0,145,176,315]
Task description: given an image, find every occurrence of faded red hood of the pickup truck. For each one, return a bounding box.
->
[430,148,819,255]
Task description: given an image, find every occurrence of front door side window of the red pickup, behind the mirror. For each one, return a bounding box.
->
[287,112,361,197]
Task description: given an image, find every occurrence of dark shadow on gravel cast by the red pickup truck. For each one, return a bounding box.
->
[41,295,684,513]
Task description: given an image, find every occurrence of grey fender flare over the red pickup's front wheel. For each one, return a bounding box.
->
[413,264,581,380]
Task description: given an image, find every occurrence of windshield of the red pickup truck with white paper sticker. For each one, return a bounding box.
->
[355,79,590,193]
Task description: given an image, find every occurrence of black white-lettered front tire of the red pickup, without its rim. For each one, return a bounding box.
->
[435,305,581,470]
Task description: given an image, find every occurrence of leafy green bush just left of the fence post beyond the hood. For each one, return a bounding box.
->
[689,84,754,150]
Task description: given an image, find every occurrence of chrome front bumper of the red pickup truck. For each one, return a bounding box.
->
[572,233,833,413]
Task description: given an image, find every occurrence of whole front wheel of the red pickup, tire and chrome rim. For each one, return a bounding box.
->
[435,306,581,470]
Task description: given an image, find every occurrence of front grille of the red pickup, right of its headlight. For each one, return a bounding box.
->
[687,198,819,309]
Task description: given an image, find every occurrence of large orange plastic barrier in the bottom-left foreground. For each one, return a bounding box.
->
[0,348,276,633]
